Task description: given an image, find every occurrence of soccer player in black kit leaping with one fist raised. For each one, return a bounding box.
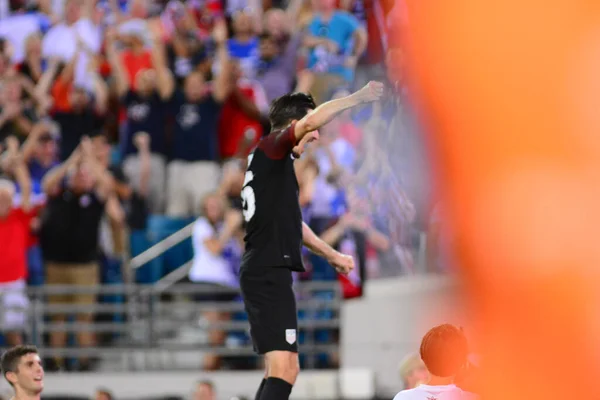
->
[240,82,384,400]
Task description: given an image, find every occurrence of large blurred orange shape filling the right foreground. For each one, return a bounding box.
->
[402,0,600,400]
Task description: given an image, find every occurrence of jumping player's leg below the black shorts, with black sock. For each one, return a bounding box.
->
[258,350,300,400]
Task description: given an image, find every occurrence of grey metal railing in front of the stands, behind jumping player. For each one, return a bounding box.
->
[0,282,341,370]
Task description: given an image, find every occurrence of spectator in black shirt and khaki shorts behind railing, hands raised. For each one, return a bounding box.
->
[40,138,112,369]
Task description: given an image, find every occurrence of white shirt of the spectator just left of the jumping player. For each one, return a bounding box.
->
[188,217,238,288]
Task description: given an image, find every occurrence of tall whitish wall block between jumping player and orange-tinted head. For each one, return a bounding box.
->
[341,275,466,398]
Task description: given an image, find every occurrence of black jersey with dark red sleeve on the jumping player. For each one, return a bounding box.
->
[241,124,304,271]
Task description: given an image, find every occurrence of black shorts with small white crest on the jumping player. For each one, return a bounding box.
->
[240,267,298,354]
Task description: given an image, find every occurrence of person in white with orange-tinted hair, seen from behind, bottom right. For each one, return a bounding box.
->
[394,324,477,400]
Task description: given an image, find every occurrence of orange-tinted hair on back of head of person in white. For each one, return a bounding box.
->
[420,324,468,377]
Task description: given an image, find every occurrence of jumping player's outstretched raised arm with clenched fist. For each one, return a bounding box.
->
[294,81,384,142]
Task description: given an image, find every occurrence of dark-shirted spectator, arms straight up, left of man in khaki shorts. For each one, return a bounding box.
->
[107,27,174,213]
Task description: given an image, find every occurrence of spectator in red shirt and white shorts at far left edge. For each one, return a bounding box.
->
[0,136,32,346]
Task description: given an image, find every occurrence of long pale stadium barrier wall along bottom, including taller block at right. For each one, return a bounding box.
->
[0,276,466,400]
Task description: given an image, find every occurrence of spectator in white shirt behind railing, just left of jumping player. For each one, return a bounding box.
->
[189,193,242,371]
